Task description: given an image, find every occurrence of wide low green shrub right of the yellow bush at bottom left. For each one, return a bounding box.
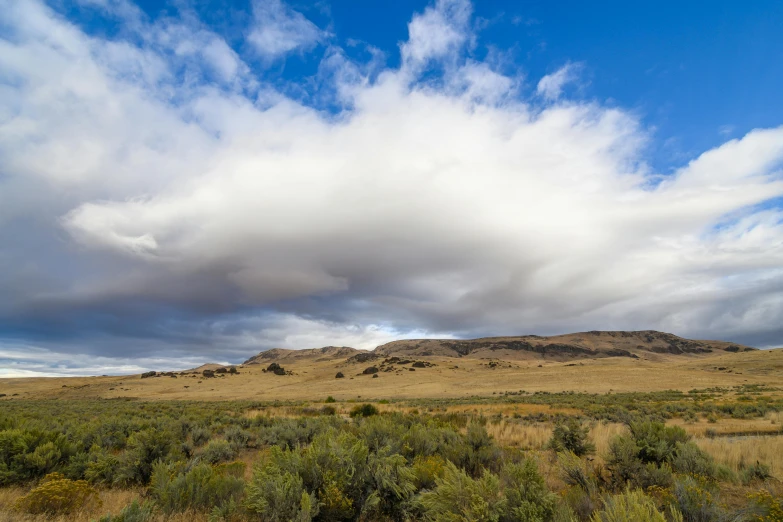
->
[150,462,245,514]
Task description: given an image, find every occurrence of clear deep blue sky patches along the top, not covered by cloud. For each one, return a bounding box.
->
[89,0,783,171]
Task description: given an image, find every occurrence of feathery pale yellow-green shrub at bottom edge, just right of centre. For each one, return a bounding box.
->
[417,463,506,522]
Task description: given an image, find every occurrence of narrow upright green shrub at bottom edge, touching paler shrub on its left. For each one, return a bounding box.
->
[500,459,557,522]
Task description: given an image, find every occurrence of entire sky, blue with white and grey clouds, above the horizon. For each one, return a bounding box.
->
[0,0,783,377]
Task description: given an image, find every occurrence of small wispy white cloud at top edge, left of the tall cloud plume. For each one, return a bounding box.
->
[247,0,328,60]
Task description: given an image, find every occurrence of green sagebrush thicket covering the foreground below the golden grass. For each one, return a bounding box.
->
[0,394,783,522]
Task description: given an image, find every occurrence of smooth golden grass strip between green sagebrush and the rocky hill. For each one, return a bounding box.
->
[0,349,783,401]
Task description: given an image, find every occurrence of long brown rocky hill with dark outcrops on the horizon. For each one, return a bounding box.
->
[245,330,755,364]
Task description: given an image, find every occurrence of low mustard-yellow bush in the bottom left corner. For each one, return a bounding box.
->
[15,473,101,515]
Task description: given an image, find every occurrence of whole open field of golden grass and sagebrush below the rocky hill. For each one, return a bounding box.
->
[0,344,783,522]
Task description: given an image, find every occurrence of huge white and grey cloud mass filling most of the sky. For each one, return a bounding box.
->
[0,0,783,371]
